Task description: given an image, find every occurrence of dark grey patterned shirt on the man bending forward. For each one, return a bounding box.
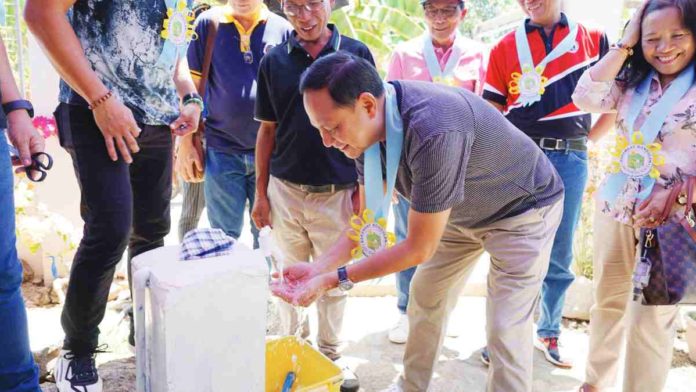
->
[357,81,563,228]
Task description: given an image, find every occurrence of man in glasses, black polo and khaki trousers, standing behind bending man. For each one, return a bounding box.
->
[252,0,374,390]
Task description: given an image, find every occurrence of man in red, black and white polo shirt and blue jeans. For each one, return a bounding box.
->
[481,0,609,368]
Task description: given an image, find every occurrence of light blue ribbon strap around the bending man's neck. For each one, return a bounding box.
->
[364,83,404,219]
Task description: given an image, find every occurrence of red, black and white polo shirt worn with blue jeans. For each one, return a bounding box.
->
[483,14,609,139]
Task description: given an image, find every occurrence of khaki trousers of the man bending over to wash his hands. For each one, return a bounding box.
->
[399,200,563,392]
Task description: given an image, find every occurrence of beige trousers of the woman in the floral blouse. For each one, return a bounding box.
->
[586,206,678,392]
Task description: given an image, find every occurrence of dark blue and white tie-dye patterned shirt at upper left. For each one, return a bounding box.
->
[60,0,192,125]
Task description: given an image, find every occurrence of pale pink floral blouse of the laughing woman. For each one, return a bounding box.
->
[573,71,696,224]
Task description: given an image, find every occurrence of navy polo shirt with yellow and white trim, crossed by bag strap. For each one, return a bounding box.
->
[188,7,292,154]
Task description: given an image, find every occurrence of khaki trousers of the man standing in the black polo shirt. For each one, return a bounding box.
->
[268,177,354,359]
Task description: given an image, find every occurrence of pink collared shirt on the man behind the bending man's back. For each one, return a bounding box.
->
[387,36,487,95]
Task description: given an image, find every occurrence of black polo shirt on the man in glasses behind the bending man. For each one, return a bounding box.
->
[256,25,374,185]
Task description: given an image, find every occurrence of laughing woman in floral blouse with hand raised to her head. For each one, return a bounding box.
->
[573,0,696,392]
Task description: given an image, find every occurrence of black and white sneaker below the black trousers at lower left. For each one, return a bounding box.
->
[53,350,102,392]
